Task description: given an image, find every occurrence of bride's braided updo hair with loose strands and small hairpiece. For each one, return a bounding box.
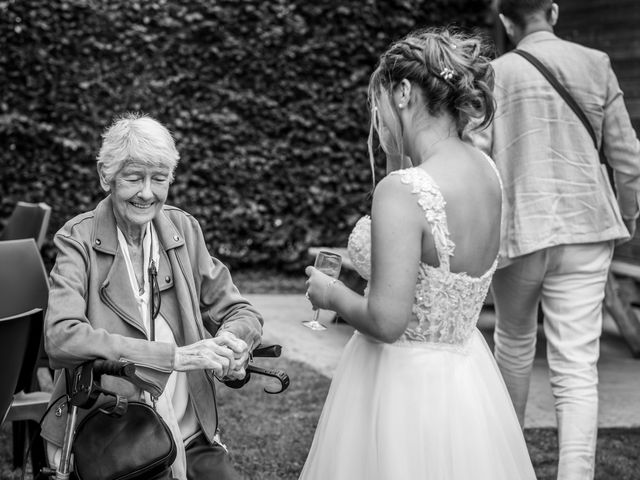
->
[369,28,495,169]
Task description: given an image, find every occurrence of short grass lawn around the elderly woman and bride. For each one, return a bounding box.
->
[0,272,640,480]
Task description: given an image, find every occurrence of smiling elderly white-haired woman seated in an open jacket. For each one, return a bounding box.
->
[42,114,262,480]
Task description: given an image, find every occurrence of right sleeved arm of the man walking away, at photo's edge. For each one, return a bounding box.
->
[601,58,640,237]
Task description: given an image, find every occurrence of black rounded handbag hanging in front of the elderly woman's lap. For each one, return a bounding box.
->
[73,402,177,480]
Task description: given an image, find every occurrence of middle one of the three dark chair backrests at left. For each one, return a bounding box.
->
[0,238,49,317]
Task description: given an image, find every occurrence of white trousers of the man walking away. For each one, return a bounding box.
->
[492,242,613,480]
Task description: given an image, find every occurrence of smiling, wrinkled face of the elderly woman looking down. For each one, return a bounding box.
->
[111,161,171,232]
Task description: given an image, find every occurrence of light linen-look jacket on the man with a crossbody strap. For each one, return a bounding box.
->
[472,32,640,258]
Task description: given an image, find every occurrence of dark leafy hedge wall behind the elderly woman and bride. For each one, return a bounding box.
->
[0,0,492,271]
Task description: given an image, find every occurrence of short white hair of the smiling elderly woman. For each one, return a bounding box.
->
[98,113,180,184]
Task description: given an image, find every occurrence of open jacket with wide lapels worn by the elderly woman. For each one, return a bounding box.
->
[42,197,263,446]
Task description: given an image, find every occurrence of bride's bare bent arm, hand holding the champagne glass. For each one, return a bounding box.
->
[306,175,429,343]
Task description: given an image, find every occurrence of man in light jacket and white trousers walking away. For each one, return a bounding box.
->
[472,0,640,480]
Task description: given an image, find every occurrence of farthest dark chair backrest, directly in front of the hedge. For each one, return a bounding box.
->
[0,202,51,248]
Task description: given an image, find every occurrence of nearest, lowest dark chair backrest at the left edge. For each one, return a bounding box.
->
[0,308,42,424]
